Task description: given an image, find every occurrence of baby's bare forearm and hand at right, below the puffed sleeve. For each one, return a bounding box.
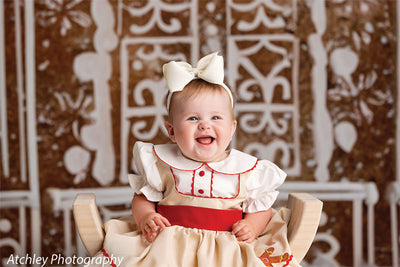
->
[232,209,271,243]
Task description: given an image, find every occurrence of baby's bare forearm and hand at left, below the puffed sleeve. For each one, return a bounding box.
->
[132,194,171,242]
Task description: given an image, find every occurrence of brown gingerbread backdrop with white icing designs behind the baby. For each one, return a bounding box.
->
[0,0,400,266]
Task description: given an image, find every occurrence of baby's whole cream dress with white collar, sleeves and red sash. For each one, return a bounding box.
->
[87,142,298,267]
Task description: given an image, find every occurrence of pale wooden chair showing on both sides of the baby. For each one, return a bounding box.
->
[73,193,322,262]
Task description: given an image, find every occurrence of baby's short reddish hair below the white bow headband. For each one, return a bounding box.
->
[167,79,235,120]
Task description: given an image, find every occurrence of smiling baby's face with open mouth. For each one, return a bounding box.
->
[165,91,236,162]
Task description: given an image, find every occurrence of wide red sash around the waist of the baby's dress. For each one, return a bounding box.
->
[157,205,243,231]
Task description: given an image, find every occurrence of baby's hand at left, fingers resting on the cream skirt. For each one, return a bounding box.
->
[139,212,171,242]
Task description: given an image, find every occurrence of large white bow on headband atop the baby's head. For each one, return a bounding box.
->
[163,52,233,110]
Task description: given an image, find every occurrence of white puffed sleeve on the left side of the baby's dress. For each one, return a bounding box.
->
[128,142,163,202]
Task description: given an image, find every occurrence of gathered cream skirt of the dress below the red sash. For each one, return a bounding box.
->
[87,208,299,267]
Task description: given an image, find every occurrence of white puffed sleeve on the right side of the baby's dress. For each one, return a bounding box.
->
[243,160,286,213]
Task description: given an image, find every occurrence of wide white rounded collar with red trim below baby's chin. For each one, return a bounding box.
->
[153,144,258,174]
